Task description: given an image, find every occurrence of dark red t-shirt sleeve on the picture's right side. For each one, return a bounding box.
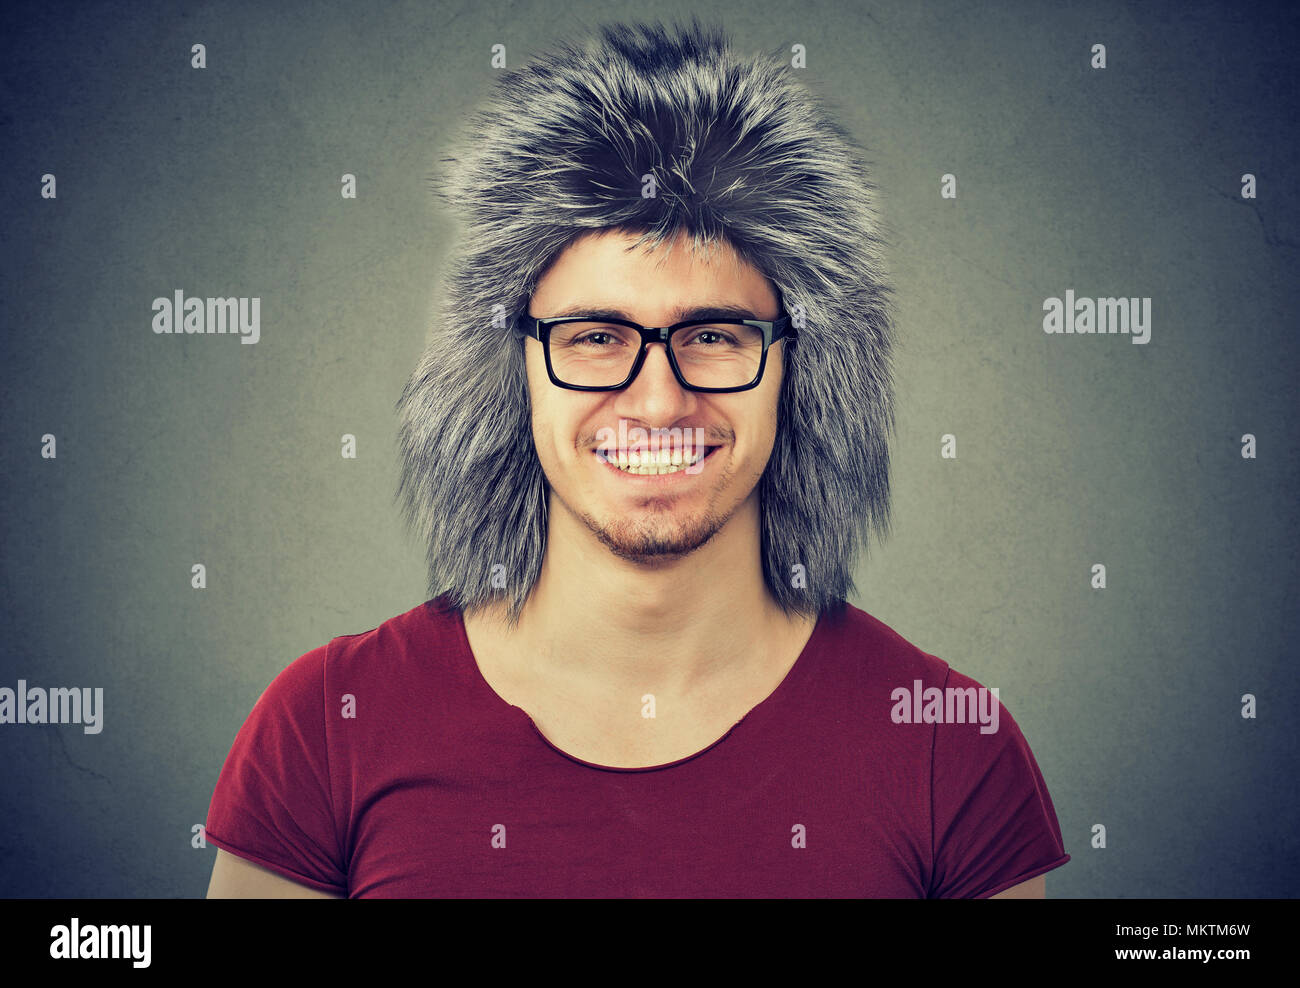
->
[930,670,1070,898]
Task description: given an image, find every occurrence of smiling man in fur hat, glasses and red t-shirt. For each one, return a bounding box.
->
[207,17,1069,897]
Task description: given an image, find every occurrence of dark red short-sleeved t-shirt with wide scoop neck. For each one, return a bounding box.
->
[207,598,1070,898]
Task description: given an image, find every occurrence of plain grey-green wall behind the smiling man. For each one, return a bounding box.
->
[0,1,1300,897]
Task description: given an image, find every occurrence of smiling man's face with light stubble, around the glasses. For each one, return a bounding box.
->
[525,230,785,564]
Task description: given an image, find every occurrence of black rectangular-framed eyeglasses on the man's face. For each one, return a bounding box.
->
[515,299,798,394]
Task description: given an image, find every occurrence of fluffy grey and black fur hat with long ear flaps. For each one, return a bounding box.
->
[397,20,894,621]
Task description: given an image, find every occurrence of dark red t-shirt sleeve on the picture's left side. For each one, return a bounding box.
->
[205,645,347,894]
